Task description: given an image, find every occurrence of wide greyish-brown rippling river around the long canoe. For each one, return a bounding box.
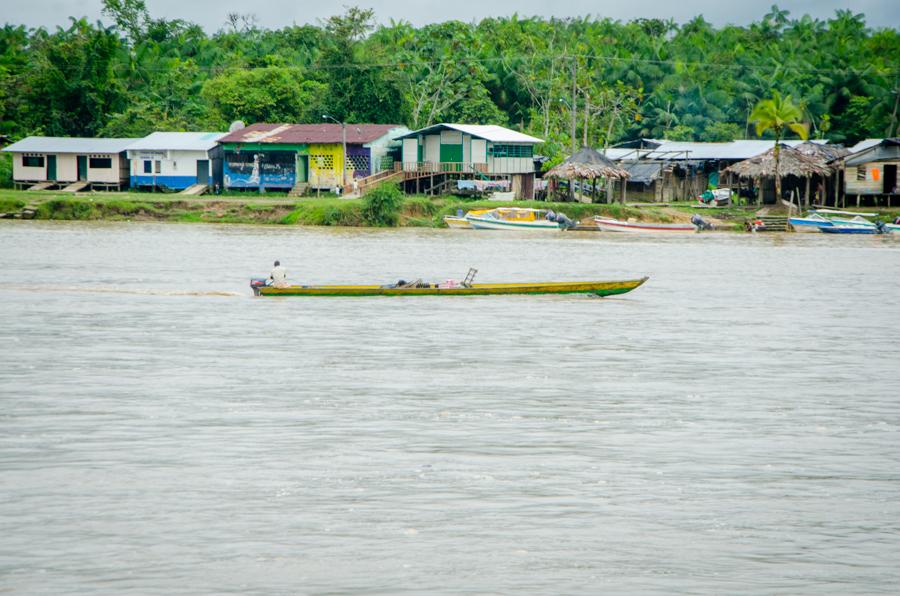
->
[0,222,900,594]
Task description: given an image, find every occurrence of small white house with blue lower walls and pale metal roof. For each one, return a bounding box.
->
[128,132,227,190]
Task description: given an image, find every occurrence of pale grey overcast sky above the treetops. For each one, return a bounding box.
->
[7,0,900,32]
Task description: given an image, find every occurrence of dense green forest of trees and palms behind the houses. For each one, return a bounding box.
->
[0,0,900,157]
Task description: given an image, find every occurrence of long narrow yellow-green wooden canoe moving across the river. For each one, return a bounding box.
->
[253,277,649,296]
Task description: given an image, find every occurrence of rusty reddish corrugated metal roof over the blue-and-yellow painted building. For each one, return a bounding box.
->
[219,122,409,145]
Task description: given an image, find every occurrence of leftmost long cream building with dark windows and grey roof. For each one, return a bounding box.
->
[3,137,137,190]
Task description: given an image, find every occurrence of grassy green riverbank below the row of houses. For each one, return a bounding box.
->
[0,190,900,231]
